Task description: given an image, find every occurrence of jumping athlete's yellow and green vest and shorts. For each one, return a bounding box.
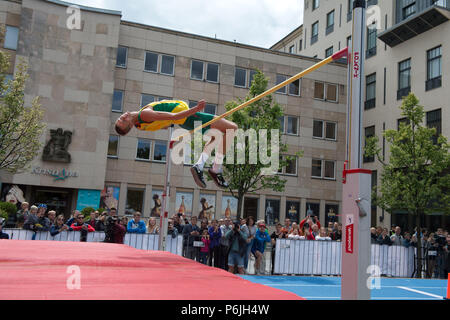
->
[136,100,214,133]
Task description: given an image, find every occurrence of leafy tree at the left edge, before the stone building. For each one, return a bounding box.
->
[0,44,45,173]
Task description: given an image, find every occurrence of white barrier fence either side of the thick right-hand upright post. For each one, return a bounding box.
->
[274,239,415,277]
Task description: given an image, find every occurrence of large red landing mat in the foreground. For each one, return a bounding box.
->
[0,240,302,300]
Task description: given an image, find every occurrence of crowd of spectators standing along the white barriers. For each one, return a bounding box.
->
[0,202,450,278]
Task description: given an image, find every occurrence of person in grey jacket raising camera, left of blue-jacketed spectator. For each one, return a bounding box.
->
[225,221,247,274]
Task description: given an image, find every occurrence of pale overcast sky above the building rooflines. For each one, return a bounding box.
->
[71,0,303,48]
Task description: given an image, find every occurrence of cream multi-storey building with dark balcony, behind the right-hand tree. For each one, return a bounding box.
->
[274,0,450,229]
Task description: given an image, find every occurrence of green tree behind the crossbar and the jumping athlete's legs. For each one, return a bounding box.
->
[224,71,301,218]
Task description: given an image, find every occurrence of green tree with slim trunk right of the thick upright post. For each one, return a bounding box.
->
[365,93,450,277]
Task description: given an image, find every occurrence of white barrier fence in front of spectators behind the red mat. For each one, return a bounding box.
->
[3,229,183,256]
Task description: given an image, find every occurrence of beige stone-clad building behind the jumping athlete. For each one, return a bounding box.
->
[0,0,346,228]
